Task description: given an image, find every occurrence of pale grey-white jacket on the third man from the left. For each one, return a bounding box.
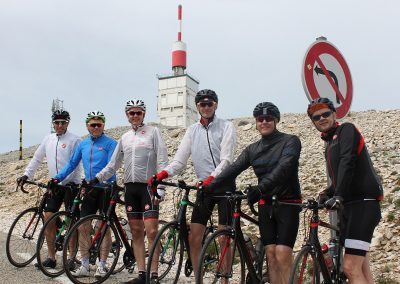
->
[96,125,168,183]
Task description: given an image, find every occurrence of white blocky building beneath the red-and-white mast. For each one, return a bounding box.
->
[157,74,198,127]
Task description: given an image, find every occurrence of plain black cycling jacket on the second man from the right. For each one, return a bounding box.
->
[209,131,301,200]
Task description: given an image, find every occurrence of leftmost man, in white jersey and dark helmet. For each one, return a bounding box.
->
[17,110,82,268]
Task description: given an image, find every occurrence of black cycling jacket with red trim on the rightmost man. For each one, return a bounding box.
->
[322,123,383,202]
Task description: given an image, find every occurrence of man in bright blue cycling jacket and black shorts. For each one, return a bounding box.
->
[51,111,117,277]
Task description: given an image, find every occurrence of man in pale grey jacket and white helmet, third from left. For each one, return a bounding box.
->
[95,99,168,283]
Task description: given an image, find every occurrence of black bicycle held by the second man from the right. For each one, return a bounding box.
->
[196,191,268,284]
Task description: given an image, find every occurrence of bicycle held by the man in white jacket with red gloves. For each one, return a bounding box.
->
[147,180,216,283]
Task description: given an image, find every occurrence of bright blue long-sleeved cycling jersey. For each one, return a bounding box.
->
[55,134,117,182]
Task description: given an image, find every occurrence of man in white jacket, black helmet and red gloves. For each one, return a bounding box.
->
[149,89,236,282]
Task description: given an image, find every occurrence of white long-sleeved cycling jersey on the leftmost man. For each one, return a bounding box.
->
[24,131,82,184]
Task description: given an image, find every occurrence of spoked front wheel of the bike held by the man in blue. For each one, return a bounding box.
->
[36,211,78,277]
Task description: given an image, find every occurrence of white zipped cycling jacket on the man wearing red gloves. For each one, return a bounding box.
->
[164,116,236,180]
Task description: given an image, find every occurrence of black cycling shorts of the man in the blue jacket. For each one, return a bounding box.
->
[81,185,110,218]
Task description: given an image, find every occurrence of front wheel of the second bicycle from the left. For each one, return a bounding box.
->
[36,211,78,278]
